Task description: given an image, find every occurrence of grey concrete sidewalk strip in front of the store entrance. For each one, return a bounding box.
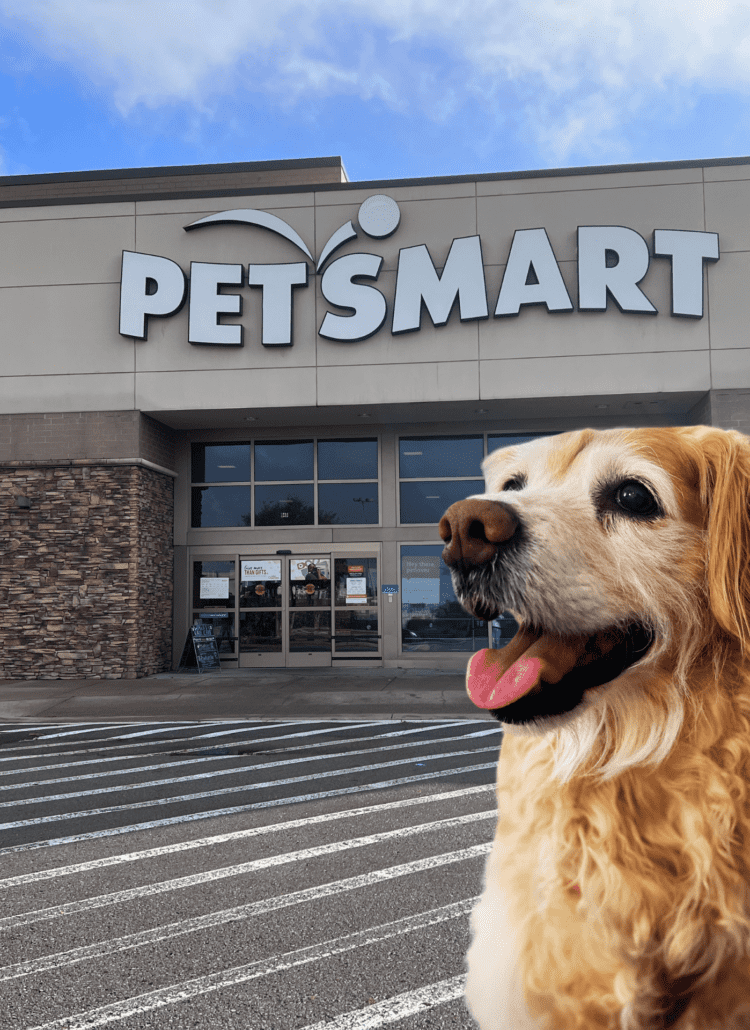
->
[0,668,495,723]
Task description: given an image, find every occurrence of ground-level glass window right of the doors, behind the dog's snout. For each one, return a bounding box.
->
[401,544,488,651]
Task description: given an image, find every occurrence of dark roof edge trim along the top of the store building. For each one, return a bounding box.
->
[0,156,750,208]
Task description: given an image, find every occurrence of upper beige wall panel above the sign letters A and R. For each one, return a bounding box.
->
[477,184,704,265]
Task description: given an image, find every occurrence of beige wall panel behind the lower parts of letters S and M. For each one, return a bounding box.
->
[316,272,482,367]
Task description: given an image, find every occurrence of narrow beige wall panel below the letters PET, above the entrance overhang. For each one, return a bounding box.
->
[135,369,315,409]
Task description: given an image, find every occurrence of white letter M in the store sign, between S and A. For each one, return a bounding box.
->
[391,236,487,334]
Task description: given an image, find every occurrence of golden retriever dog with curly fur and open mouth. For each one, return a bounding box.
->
[440,425,750,1030]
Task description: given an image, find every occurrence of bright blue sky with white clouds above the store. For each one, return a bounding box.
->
[0,0,750,179]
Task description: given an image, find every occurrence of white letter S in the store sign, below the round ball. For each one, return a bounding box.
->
[319,254,386,341]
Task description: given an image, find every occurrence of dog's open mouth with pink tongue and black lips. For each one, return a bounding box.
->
[467,623,653,723]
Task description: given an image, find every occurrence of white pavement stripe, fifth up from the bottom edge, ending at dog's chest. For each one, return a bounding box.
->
[0,784,497,890]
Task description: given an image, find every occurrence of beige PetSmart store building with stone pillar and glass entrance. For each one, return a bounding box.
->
[0,158,750,679]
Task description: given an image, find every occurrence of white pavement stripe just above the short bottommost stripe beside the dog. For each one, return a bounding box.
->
[23,901,468,1030]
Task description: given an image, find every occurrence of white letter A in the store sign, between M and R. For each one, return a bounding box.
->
[495,229,573,318]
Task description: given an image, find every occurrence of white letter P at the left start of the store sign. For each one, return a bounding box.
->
[120,250,185,340]
